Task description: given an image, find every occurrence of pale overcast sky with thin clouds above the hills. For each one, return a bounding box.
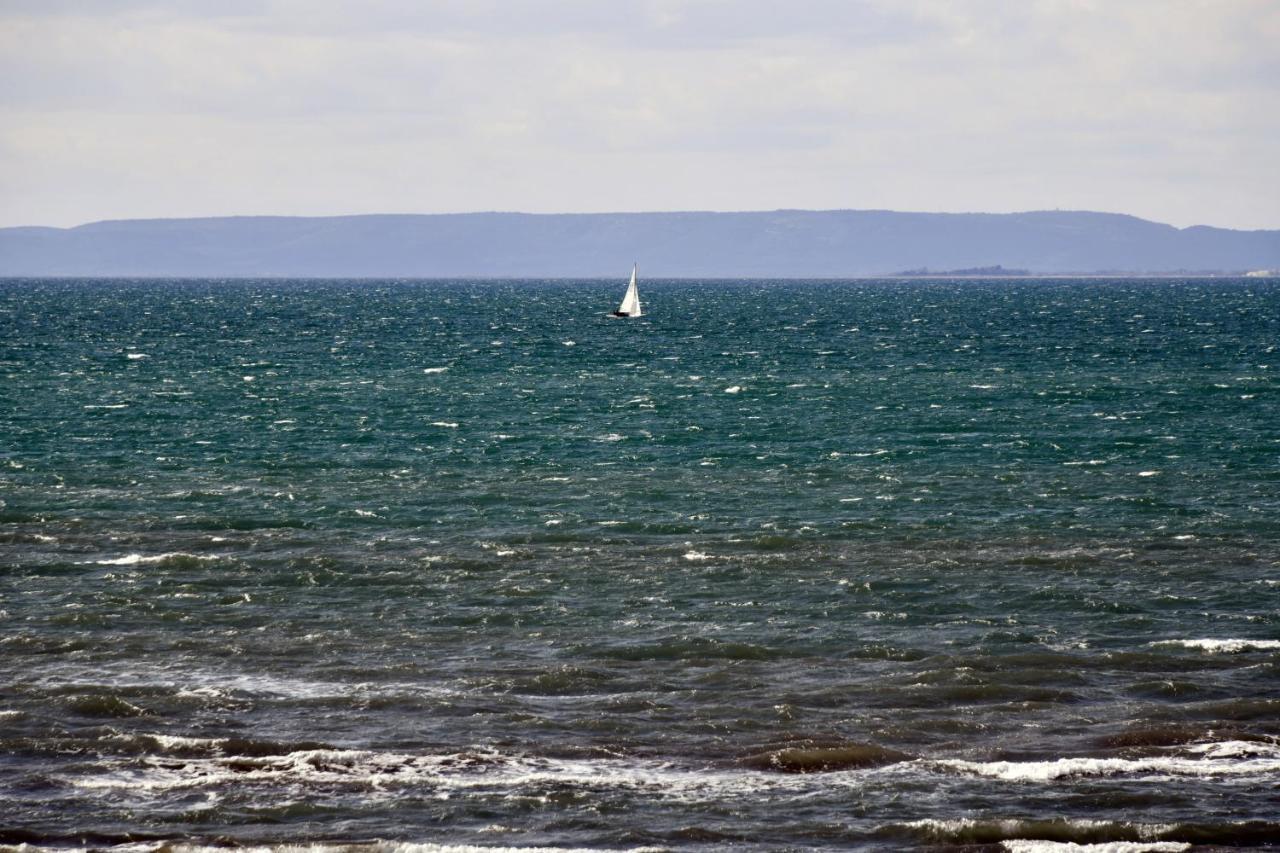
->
[0,0,1280,228]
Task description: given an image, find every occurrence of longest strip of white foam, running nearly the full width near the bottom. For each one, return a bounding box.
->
[60,737,1280,809]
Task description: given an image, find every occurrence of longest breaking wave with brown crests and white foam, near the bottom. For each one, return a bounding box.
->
[63,733,1280,799]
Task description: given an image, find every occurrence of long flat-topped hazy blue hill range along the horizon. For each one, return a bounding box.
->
[0,210,1280,278]
